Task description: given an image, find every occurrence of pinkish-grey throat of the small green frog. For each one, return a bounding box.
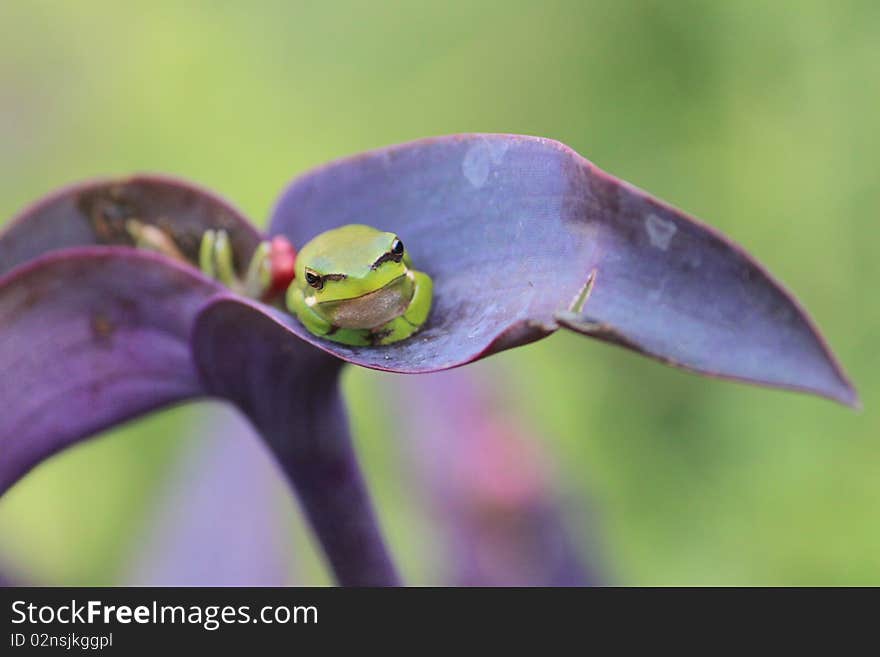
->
[320,272,415,329]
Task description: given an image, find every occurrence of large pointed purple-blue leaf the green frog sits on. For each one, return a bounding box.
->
[270,135,857,404]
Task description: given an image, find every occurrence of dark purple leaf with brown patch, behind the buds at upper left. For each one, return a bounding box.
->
[0,175,262,275]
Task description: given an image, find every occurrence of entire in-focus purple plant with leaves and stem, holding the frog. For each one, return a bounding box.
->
[0,135,858,585]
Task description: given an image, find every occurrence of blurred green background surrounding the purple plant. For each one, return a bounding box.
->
[0,0,880,584]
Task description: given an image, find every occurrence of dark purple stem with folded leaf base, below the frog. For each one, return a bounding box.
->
[193,297,399,586]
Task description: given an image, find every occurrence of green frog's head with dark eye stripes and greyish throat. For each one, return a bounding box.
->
[296,224,413,328]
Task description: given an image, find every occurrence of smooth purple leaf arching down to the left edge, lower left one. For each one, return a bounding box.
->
[0,247,221,494]
